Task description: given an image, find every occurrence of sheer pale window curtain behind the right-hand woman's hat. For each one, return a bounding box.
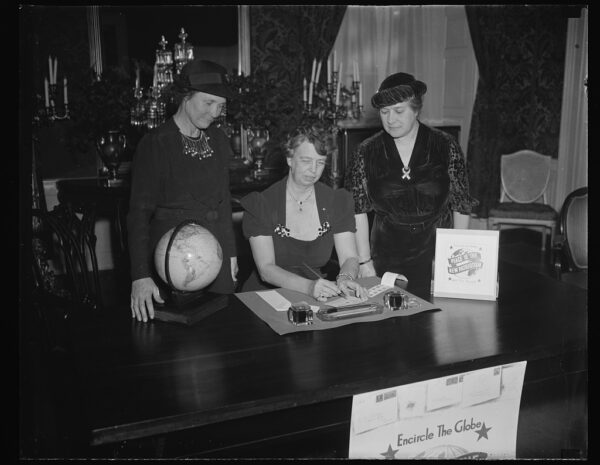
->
[334,5,446,124]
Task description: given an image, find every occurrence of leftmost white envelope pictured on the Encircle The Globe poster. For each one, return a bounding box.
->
[352,388,398,434]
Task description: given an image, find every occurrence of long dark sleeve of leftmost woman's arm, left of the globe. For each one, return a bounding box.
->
[127,133,161,281]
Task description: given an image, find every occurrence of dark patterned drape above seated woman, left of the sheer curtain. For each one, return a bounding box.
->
[250,5,346,171]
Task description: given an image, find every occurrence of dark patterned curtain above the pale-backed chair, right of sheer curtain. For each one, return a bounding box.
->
[465,5,568,218]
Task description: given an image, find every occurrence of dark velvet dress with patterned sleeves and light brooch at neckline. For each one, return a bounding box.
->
[346,123,476,286]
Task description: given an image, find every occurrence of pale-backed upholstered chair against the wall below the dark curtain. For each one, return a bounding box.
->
[488,150,558,250]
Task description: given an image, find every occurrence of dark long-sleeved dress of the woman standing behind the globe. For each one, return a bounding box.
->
[127,118,236,294]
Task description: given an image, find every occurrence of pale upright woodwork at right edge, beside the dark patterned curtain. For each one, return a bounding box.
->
[553,8,588,210]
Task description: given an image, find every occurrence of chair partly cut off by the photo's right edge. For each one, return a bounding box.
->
[552,187,588,289]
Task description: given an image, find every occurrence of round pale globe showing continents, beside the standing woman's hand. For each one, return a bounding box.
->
[154,220,223,292]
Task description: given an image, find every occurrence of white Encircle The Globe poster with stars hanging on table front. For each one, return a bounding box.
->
[348,361,527,460]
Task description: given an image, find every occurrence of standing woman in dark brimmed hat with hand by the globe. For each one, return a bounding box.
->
[127,59,237,321]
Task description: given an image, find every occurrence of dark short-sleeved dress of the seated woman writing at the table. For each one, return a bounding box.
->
[241,177,356,292]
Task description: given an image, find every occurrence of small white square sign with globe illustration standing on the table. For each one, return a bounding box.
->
[433,228,500,300]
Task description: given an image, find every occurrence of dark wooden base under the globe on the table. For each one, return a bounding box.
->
[154,291,229,325]
